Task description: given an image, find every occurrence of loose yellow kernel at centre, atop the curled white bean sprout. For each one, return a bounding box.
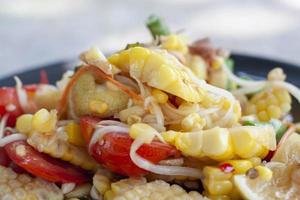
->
[129,123,157,144]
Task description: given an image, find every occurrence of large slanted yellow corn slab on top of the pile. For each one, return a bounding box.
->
[108,47,206,102]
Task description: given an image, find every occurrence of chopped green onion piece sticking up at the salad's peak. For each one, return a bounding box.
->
[146,15,171,38]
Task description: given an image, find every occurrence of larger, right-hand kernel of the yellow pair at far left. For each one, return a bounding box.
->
[32,108,57,133]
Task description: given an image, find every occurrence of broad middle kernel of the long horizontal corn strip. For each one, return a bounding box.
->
[202,127,233,159]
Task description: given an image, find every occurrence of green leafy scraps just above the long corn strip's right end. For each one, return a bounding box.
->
[243,119,288,143]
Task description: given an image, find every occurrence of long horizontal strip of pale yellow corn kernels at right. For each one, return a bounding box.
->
[162,126,276,161]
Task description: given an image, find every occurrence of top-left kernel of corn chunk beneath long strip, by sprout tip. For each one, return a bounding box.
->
[203,166,232,180]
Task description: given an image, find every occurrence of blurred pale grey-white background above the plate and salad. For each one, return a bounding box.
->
[0,0,300,78]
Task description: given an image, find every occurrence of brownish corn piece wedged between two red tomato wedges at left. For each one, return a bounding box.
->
[27,132,97,170]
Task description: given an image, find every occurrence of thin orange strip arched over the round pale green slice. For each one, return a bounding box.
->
[57,65,143,118]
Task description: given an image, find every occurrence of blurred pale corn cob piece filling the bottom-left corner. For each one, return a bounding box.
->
[0,165,63,200]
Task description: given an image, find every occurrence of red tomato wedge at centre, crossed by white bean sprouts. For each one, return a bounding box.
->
[80,117,180,176]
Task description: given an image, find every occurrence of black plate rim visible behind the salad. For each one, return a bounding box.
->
[0,54,300,121]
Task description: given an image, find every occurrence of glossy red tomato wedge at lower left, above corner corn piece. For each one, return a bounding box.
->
[4,141,89,184]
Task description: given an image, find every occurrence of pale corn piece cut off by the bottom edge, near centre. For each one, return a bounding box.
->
[104,178,207,200]
